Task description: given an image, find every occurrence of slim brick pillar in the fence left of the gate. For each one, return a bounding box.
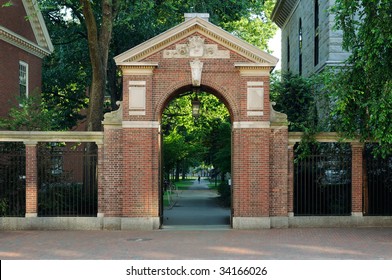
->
[24,142,38,217]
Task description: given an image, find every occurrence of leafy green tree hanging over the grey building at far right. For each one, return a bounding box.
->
[327,0,392,155]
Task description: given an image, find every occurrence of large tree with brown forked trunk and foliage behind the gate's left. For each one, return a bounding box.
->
[39,0,276,130]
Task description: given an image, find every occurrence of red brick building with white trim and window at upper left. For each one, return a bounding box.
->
[0,0,53,117]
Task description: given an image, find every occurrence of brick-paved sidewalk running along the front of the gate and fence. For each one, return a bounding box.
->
[0,228,392,260]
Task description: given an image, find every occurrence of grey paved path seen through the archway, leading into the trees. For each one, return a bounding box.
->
[163,179,230,229]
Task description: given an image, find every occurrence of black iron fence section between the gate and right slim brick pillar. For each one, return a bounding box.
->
[294,143,352,216]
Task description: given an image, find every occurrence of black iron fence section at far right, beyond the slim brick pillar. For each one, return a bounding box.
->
[363,144,392,216]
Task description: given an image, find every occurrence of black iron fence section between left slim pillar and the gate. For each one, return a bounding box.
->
[38,143,98,217]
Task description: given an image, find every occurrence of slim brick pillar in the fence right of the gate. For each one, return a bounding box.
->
[351,143,364,216]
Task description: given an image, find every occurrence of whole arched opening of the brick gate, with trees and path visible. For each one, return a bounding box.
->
[160,86,232,229]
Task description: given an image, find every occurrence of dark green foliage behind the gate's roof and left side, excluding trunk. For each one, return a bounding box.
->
[38,0,276,128]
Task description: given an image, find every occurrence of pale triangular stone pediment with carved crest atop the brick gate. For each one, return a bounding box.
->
[114,16,278,69]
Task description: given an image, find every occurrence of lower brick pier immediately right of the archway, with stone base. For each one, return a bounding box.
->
[232,122,271,229]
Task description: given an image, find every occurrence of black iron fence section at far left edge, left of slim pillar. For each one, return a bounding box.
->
[0,143,26,217]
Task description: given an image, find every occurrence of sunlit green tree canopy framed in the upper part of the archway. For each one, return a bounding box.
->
[162,92,231,179]
